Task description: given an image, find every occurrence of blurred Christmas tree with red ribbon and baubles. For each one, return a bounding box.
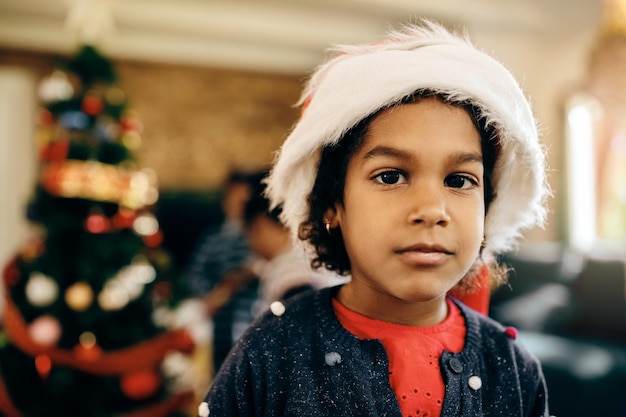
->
[0,46,194,417]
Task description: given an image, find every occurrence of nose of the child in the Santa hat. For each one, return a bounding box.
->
[408,185,450,226]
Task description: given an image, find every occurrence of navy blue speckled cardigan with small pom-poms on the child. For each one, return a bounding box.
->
[200,287,548,417]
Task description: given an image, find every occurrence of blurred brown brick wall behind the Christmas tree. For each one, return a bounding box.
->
[0,49,304,191]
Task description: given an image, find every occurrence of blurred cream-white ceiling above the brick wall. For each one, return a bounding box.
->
[0,0,602,74]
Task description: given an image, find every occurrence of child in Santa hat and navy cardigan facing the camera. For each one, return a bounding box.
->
[199,22,548,417]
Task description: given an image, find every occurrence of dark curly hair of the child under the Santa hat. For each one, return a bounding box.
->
[298,90,505,288]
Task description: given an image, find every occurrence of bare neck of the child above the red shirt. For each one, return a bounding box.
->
[336,283,448,326]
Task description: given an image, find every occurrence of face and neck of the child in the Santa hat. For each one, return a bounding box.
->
[332,98,485,325]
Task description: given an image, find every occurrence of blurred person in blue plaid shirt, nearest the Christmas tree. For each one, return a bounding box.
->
[186,170,267,371]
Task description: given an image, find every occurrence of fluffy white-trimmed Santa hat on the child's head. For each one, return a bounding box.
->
[267,21,549,253]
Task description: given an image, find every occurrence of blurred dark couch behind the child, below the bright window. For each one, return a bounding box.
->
[490,243,626,417]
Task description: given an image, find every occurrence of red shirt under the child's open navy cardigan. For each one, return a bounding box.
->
[333,299,465,417]
